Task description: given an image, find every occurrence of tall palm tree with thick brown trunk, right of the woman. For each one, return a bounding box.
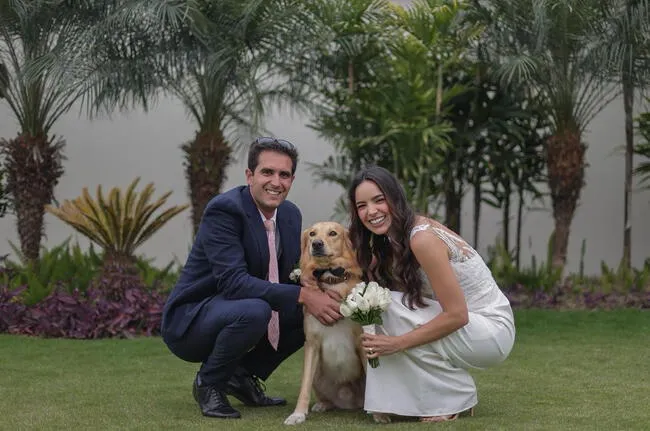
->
[474,0,618,268]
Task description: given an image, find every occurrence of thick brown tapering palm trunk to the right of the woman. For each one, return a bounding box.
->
[547,128,586,268]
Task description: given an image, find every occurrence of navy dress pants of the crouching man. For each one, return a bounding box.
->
[162,296,305,389]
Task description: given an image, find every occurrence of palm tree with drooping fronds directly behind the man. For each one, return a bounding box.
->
[49,0,314,236]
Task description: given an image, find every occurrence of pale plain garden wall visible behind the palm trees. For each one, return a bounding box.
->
[0,95,650,273]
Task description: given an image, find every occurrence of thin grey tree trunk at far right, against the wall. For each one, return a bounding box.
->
[621,73,634,268]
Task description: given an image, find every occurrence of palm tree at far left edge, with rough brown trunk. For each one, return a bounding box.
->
[0,0,117,261]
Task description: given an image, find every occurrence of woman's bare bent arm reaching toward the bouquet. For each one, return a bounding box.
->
[390,231,469,350]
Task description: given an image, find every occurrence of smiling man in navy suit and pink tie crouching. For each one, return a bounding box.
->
[161,138,342,418]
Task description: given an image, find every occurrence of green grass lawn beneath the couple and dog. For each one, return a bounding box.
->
[0,310,650,431]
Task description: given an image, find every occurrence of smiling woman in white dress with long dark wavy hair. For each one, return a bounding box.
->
[348,167,515,423]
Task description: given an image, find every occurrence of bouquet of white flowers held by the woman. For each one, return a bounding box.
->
[340,281,393,368]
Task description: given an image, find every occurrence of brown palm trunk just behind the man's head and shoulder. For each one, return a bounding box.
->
[181,132,232,235]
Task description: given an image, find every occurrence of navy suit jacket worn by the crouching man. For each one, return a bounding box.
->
[161,186,302,341]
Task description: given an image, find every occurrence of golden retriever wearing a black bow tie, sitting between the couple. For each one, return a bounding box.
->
[284,222,366,425]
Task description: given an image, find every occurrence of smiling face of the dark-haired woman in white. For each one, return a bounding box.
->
[355,180,392,235]
